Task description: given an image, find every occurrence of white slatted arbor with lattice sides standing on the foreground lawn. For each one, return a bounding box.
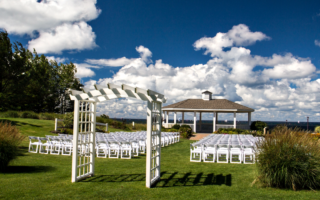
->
[69,83,166,188]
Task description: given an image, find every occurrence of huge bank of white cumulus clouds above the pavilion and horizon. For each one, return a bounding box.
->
[85,25,320,121]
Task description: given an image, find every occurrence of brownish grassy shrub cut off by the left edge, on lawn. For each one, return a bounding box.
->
[0,122,25,171]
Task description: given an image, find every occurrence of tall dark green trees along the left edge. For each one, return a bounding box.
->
[0,31,82,113]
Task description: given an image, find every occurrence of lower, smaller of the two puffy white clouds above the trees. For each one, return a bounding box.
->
[28,22,97,54]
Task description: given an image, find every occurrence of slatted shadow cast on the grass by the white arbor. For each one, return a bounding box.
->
[81,172,232,188]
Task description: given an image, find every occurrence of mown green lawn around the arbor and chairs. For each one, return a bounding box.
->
[0,118,319,200]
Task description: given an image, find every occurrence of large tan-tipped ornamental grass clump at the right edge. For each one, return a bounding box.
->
[256,126,320,190]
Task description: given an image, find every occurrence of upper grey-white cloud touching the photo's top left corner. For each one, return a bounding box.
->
[0,0,101,35]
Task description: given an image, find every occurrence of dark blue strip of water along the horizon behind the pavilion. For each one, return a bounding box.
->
[113,118,320,130]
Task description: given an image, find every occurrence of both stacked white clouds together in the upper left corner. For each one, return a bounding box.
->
[0,0,101,54]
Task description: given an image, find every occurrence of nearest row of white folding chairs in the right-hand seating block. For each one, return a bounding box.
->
[190,144,255,164]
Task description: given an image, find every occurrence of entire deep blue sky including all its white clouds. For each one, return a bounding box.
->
[0,0,320,121]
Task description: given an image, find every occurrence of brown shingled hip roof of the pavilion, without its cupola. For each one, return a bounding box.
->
[162,99,254,112]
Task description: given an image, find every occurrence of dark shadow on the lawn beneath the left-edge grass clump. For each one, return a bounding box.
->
[2,166,55,174]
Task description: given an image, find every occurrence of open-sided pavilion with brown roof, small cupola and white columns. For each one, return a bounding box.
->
[162,91,254,133]
